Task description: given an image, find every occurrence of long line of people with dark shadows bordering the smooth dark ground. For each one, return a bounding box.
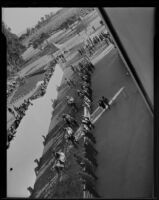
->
[75,59,99,197]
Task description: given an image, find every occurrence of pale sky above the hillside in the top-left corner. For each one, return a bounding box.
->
[2,7,61,35]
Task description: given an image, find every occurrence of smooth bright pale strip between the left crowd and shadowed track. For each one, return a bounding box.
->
[7,65,63,198]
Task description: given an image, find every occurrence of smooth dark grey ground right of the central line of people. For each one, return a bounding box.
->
[92,47,153,198]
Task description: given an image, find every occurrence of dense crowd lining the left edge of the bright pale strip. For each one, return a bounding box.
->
[7,62,55,148]
